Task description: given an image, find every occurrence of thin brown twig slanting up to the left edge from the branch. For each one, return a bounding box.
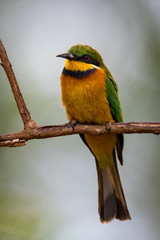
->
[0,40,35,127]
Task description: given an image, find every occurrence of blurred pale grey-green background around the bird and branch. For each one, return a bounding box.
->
[0,0,160,240]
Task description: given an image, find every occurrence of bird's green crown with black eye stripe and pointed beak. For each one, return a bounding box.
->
[57,44,106,69]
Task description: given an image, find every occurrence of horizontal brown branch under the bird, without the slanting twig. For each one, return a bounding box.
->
[0,122,160,147]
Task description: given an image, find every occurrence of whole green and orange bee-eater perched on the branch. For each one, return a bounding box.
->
[57,44,131,223]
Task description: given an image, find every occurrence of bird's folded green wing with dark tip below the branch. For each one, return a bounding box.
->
[106,76,124,164]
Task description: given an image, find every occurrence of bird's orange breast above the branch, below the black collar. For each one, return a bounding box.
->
[61,68,113,124]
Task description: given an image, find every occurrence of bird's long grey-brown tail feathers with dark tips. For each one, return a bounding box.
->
[96,154,131,223]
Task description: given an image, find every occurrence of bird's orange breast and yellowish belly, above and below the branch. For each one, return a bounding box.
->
[61,68,116,169]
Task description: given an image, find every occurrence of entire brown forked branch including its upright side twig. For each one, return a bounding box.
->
[0,40,160,147]
